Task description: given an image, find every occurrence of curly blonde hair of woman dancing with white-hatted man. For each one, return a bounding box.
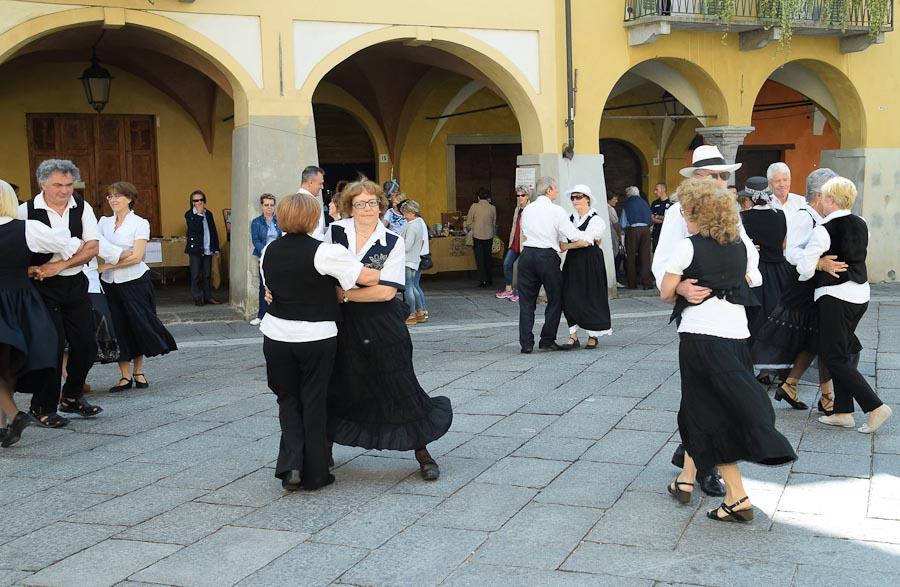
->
[678,178,740,245]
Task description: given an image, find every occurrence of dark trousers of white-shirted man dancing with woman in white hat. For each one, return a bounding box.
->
[519,247,562,349]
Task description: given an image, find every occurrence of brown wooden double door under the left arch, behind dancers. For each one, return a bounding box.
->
[26,114,161,236]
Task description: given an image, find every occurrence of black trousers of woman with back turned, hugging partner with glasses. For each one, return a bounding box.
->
[263,337,337,486]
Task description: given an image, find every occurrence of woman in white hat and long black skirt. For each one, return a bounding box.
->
[559,184,612,349]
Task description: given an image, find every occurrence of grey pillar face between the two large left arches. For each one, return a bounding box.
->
[229,115,319,318]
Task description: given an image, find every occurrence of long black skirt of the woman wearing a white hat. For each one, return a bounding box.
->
[562,246,612,334]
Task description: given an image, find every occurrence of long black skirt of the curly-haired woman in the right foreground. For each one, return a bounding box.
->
[678,333,797,469]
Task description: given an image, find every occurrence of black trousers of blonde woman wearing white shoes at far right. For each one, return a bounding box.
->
[816,296,883,414]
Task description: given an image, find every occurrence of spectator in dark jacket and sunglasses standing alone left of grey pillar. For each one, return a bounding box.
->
[184,190,221,306]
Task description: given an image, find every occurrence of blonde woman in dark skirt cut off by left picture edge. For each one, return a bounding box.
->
[0,180,82,448]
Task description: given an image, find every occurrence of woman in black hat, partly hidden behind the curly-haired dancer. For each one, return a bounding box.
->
[739,177,796,366]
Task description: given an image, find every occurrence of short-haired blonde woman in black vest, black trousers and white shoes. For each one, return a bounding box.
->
[797,177,892,434]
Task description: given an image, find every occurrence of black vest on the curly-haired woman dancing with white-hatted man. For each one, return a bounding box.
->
[669,235,759,324]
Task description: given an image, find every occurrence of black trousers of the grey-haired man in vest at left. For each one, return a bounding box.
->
[17,273,97,414]
